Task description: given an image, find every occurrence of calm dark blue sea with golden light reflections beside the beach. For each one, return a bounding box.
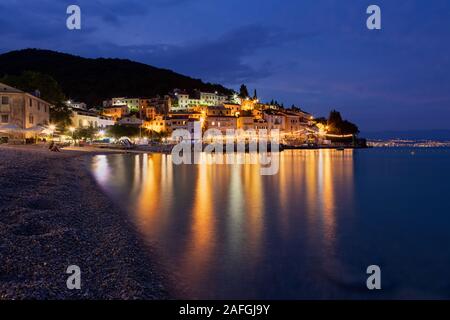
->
[92,148,450,299]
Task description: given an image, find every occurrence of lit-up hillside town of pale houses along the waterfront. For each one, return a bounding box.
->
[0,83,358,148]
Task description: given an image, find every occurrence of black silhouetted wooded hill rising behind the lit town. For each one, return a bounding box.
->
[0,49,231,105]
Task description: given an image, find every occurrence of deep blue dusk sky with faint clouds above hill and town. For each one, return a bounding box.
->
[0,0,450,131]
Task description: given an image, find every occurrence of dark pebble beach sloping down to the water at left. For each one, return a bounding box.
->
[0,146,171,299]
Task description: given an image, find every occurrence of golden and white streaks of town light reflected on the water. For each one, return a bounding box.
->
[89,150,353,298]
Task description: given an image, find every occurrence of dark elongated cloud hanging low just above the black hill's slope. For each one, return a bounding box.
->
[74,25,309,84]
